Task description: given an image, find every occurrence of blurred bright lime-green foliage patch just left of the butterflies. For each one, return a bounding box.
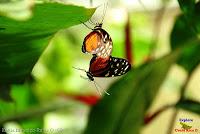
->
[33,32,77,100]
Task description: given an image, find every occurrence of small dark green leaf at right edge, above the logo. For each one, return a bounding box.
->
[176,100,200,115]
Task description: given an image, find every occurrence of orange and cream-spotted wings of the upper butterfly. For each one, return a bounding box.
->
[82,27,113,58]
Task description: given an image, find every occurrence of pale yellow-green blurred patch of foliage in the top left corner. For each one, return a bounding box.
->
[0,0,34,20]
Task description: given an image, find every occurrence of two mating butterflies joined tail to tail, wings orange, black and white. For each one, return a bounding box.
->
[76,23,131,94]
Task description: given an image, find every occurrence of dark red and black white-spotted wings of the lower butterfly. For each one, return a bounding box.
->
[89,56,131,77]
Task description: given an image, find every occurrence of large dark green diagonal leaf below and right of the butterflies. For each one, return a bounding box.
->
[85,51,178,134]
